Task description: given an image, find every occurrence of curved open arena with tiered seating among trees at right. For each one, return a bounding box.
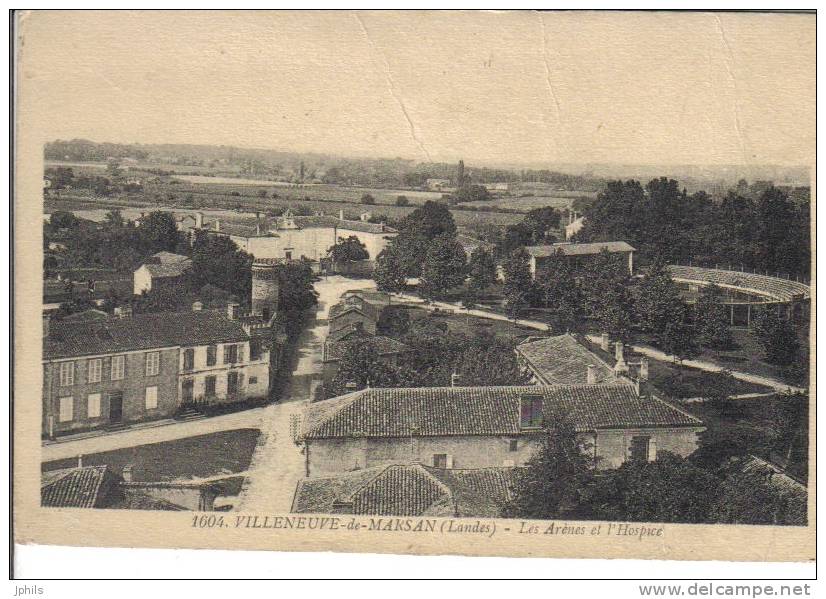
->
[668,265,811,327]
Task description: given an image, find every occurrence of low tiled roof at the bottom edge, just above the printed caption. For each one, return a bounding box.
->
[292,464,513,517]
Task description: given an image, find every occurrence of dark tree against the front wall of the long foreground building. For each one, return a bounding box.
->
[502,418,594,520]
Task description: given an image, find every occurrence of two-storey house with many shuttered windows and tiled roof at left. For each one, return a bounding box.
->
[42,303,270,437]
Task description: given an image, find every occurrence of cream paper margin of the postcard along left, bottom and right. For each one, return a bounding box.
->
[12,13,816,561]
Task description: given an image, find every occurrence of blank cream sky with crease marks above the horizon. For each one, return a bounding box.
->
[18,11,815,166]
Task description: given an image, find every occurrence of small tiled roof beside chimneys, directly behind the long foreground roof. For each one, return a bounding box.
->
[516,335,617,385]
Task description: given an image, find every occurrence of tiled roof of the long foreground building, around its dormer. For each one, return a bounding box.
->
[304,383,702,439]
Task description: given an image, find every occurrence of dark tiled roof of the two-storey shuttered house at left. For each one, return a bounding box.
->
[43,310,249,359]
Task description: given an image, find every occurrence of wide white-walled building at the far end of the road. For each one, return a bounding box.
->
[179,212,398,262]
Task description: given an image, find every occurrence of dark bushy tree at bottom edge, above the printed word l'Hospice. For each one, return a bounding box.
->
[587,451,720,523]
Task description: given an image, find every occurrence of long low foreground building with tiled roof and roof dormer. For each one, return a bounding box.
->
[302,382,703,476]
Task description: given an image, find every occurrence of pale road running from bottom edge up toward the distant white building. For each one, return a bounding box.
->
[235,276,374,513]
